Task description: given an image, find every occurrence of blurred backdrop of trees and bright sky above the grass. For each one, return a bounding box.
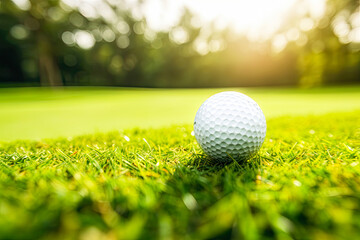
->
[0,0,360,87]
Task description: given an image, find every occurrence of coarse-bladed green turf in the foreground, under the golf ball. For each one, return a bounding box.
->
[0,110,360,239]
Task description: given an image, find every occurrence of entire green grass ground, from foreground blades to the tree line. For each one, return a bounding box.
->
[0,86,360,239]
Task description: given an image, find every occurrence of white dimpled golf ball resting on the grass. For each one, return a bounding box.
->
[194,91,266,161]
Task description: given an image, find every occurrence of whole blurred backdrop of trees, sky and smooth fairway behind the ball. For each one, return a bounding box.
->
[0,0,360,141]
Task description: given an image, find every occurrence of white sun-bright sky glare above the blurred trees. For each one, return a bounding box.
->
[136,0,326,41]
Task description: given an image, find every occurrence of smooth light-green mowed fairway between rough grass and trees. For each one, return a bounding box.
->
[0,87,360,142]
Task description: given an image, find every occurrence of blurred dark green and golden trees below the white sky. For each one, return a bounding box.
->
[0,0,360,87]
